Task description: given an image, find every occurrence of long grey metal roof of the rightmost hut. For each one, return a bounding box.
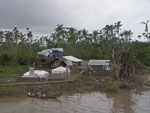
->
[88,60,110,66]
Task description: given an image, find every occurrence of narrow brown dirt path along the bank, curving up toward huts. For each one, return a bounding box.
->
[0,70,84,86]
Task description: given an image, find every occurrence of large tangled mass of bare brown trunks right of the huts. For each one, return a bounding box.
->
[111,47,135,81]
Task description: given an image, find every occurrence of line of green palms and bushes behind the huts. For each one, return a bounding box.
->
[0,21,150,66]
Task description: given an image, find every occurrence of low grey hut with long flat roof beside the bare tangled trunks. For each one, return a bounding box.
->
[88,60,110,71]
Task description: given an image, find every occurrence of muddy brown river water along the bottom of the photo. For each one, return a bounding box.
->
[0,90,150,113]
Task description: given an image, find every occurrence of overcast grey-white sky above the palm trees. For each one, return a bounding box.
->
[0,0,150,39]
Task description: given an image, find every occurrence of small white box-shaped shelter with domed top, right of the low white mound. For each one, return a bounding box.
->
[52,67,71,78]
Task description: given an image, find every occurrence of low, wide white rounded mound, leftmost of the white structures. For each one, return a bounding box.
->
[22,70,49,78]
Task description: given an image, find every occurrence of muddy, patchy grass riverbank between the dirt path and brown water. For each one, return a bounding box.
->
[0,69,150,96]
